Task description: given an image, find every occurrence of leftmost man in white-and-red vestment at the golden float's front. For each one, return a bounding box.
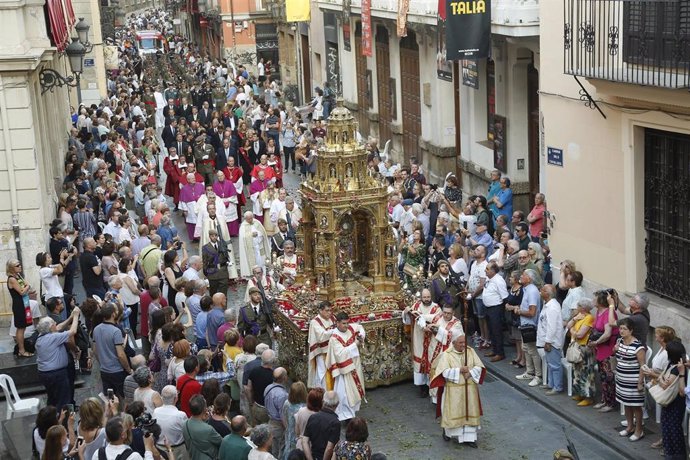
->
[307,300,335,388]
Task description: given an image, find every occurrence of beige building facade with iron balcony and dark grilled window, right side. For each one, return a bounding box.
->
[540,0,690,341]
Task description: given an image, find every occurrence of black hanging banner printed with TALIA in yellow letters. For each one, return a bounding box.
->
[445,0,491,61]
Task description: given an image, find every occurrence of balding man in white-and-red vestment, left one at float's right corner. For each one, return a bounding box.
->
[403,288,441,396]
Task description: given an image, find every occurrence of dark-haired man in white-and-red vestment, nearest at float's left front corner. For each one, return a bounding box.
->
[326,311,364,421]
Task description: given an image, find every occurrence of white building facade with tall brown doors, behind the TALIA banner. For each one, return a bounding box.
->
[290,0,540,203]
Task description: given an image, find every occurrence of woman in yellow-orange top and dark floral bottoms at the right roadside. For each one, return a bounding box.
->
[566,298,596,406]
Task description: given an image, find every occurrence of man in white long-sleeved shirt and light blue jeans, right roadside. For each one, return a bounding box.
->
[537,284,565,396]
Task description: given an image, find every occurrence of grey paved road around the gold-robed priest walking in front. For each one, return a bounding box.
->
[359,374,624,460]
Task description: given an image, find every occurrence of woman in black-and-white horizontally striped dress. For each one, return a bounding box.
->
[614,318,646,442]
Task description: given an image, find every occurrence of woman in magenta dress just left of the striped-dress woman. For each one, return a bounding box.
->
[588,291,618,412]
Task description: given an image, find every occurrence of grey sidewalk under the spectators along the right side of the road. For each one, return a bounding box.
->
[480,346,662,459]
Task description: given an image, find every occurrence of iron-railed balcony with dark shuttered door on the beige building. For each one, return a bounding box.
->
[563,0,690,89]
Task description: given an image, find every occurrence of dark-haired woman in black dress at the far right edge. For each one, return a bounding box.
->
[659,340,688,460]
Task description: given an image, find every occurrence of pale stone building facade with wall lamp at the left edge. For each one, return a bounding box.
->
[0,0,76,318]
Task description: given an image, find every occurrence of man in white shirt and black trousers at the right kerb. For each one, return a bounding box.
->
[482,261,508,363]
